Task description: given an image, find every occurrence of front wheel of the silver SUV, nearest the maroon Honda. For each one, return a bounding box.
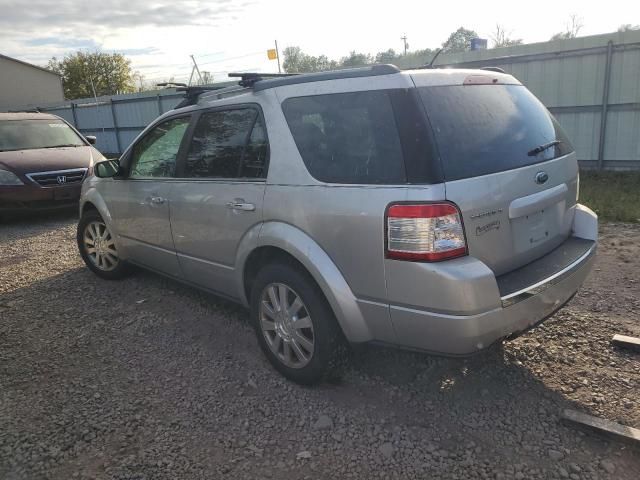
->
[76,210,131,280]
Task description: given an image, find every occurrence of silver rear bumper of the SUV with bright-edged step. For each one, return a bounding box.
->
[390,204,597,355]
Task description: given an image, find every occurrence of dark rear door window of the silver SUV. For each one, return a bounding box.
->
[184,108,268,179]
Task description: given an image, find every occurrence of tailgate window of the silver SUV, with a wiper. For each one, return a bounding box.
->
[418,85,573,180]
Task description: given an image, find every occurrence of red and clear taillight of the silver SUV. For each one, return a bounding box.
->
[386,203,467,262]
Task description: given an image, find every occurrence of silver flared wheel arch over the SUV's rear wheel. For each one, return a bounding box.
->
[236,222,373,342]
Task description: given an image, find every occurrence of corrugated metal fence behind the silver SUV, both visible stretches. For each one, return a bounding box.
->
[25,31,640,169]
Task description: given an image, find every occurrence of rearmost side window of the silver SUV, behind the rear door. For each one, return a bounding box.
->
[282,91,407,184]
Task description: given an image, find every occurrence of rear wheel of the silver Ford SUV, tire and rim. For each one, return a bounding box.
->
[251,264,348,385]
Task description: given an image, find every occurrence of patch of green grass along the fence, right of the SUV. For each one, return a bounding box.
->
[579,170,640,223]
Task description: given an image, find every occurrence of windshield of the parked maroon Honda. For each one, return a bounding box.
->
[0,119,86,152]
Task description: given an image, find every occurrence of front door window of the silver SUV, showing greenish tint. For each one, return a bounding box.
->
[129,117,190,178]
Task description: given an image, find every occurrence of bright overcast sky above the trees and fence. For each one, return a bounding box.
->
[0,0,640,81]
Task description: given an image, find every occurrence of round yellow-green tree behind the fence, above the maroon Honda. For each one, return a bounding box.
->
[47,51,135,100]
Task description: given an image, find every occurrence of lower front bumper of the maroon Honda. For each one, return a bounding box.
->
[0,184,82,213]
